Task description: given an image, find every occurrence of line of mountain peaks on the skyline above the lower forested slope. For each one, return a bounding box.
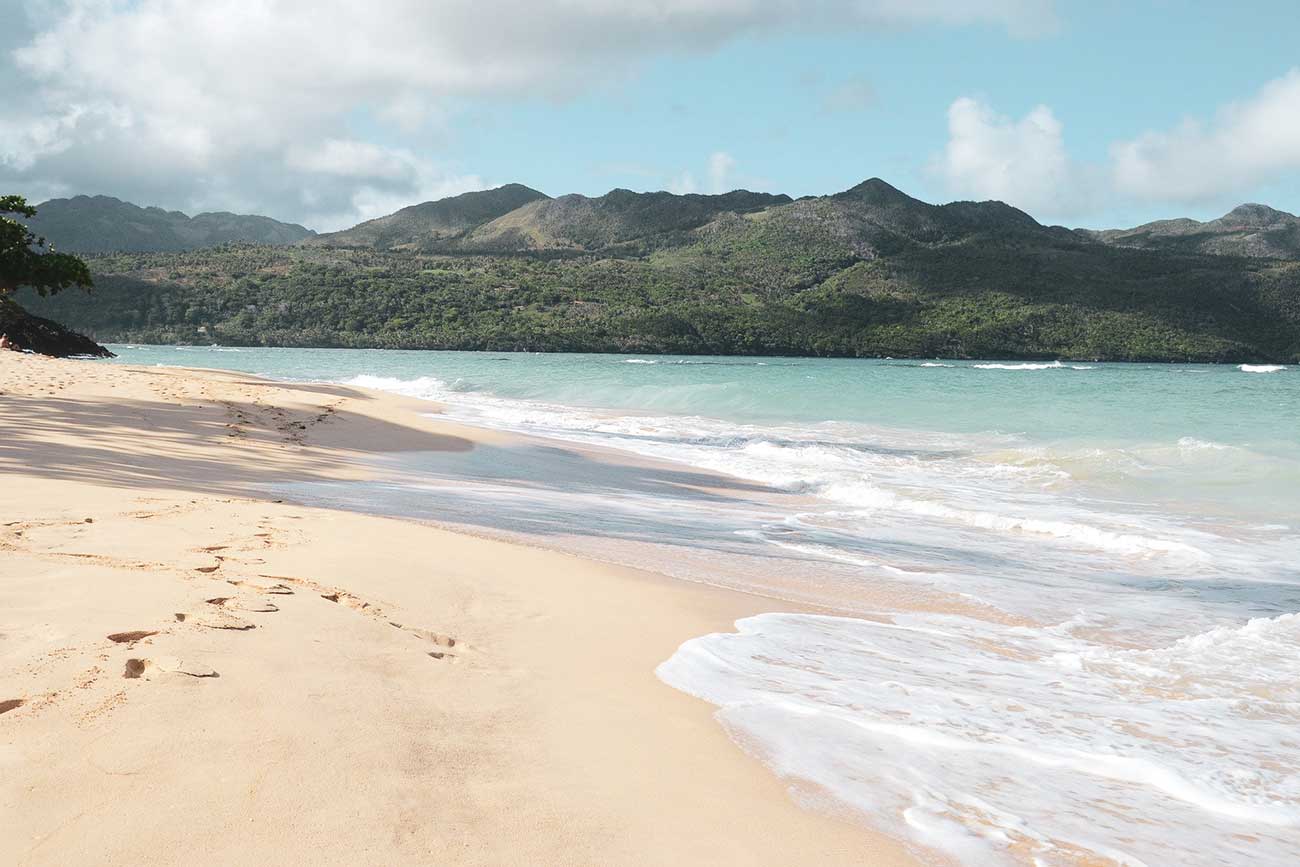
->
[27,185,1300,259]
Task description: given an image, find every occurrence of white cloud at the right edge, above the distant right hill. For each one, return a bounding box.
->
[1112,69,1300,201]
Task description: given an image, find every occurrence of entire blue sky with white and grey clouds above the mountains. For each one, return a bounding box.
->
[0,0,1300,231]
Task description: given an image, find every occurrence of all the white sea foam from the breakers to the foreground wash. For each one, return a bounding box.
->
[330,365,1300,866]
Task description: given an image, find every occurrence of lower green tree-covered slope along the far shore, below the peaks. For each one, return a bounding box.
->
[20,227,1300,361]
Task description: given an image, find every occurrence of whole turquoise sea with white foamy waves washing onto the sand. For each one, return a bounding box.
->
[109,346,1300,866]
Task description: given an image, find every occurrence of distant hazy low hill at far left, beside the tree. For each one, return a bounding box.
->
[27,196,316,253]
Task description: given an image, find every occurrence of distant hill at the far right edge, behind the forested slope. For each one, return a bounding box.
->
[1082,204,1300,259]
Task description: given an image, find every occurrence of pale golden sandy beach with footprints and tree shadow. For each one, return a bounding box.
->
[0,352,913,866]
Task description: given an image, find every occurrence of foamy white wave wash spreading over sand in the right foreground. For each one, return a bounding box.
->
[657,614,1300,867]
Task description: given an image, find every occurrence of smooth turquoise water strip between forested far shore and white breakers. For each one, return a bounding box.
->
[112,346,1300,447]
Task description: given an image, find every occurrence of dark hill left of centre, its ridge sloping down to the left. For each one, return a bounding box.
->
[308,183,549,250]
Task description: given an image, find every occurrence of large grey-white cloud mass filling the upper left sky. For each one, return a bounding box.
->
[0,0,1054,227]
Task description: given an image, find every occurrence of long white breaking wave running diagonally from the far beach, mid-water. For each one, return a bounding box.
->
[332,376,1218,568]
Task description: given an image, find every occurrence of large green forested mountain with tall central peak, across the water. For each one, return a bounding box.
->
[20,179,1300,361]
